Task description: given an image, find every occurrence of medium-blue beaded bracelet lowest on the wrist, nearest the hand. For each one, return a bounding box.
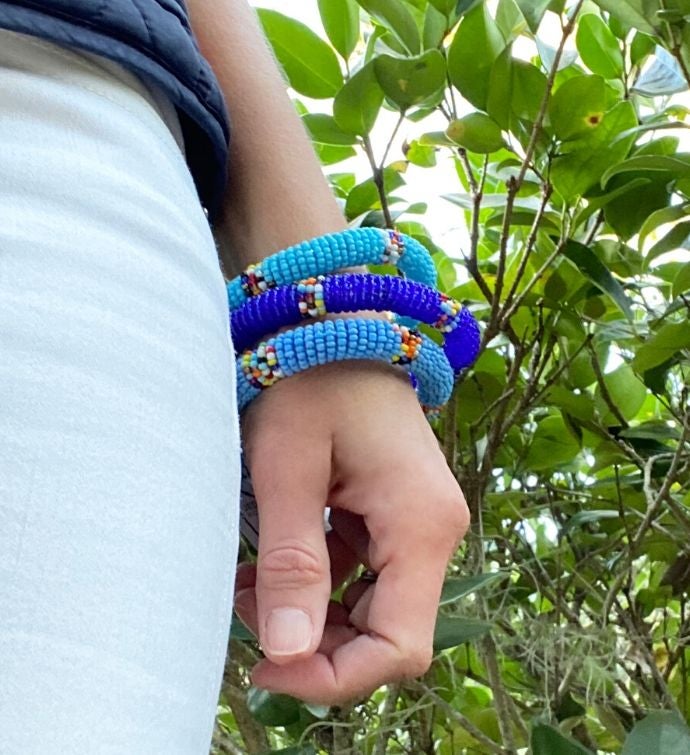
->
[237,318,455,411]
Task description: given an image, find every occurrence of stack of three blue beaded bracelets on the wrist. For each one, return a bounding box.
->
[227,228,479,413]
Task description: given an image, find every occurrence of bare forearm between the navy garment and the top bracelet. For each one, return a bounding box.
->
[187,0,346,274]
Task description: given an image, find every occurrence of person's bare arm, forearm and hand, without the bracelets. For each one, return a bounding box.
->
[188,0,468,703]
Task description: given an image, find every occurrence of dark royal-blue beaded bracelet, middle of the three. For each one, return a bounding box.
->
[230,273,479,372]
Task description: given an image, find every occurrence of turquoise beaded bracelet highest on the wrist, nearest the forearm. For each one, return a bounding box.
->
[227,227,436,310]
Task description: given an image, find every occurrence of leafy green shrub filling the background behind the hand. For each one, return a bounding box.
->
[214,0,690,755]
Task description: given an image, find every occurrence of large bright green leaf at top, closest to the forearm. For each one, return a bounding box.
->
[257,8,343,99]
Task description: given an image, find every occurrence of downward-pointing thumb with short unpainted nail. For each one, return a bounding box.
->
[251,422,331,665]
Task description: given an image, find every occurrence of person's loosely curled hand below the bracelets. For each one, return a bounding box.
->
[235,361,469,705]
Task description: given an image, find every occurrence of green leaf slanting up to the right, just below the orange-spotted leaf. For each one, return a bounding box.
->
[551,102,637,202]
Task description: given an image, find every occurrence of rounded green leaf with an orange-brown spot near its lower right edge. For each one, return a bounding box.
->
[549,76,606,141]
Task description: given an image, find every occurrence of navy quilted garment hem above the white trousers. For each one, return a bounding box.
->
[0,0,229,224]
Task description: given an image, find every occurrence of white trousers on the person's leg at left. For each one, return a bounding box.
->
[0,30,240,755]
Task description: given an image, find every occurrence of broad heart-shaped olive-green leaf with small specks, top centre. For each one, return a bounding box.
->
[373,50,446,112]
